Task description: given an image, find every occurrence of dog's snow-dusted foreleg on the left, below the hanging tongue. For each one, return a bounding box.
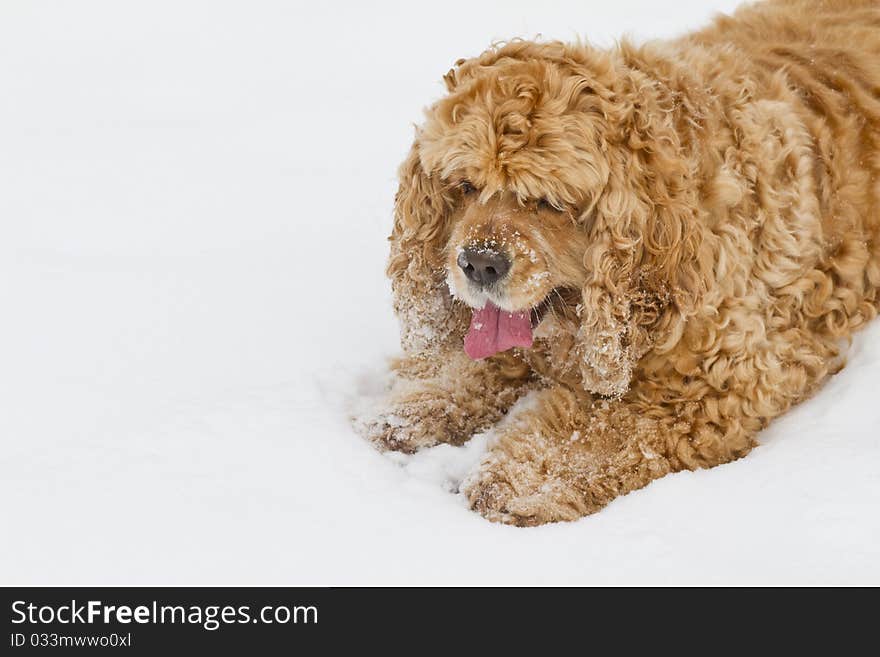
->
[355,349,533,453]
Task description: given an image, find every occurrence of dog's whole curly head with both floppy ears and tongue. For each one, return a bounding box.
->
[389,42,712,395]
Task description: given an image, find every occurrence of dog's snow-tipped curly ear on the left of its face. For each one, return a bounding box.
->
[387,142,467,354]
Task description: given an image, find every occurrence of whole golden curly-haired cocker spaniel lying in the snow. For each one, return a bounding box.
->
[364,0,880,524]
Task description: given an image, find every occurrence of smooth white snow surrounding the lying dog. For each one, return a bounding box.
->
[0,0,880,584]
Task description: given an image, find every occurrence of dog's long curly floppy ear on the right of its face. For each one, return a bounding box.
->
[577,65,713,396]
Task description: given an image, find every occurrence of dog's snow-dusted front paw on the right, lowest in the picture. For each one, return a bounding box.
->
[461,449,590,527]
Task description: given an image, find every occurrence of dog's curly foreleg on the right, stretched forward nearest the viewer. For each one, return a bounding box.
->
[462,387,757,525]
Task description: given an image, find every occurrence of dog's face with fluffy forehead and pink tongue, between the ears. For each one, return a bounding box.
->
[420,53,608,358]
